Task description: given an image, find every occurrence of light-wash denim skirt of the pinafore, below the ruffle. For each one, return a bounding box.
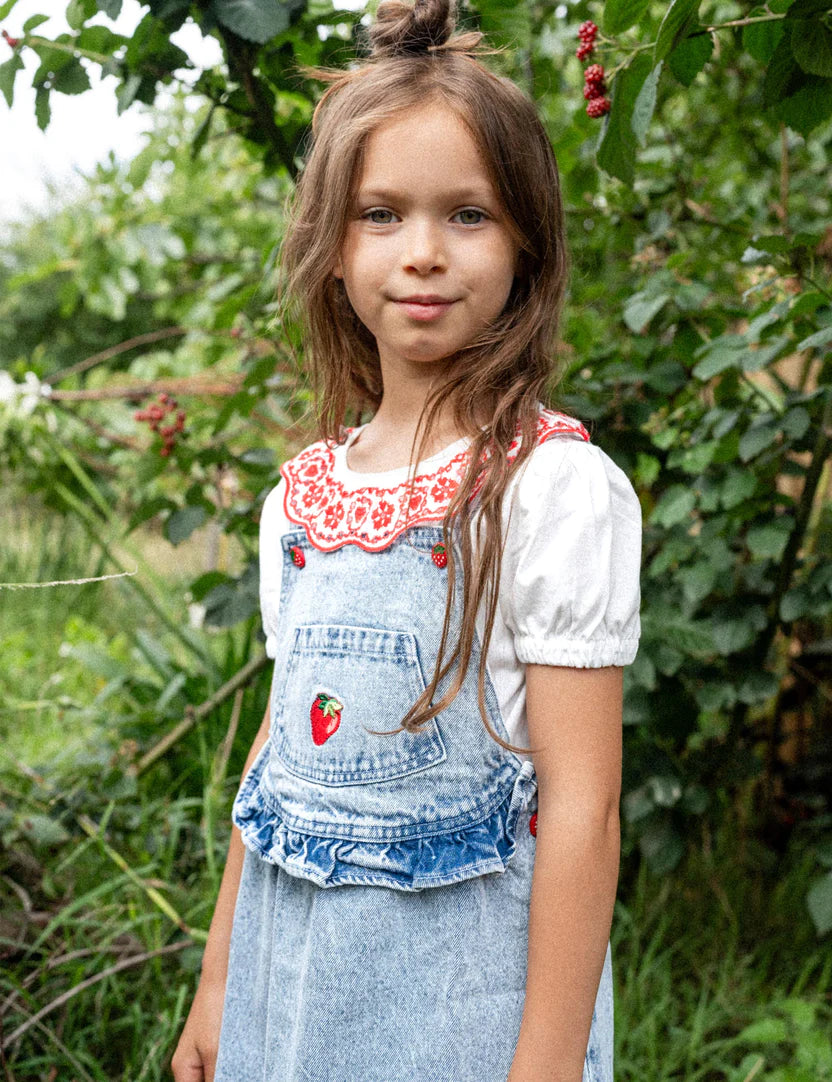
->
[210,796,612,1082]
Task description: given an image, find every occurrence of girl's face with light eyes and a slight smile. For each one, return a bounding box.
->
[333,104,519,365]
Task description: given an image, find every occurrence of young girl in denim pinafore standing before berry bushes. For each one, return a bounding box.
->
[173,0,640,1082]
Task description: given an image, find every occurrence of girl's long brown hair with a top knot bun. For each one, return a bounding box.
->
[282,0,569,753]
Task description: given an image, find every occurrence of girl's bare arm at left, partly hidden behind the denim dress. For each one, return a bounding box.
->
[171,707,269,1082]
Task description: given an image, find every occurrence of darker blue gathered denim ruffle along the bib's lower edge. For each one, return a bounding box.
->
[233,745,537,890]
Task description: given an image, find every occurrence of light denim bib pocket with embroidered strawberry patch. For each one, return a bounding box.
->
[272,624,446,786]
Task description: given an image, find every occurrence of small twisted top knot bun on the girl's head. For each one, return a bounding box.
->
[369,0,483,60]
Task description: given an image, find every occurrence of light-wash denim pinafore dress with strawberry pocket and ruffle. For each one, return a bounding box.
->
[215,411,612,1082]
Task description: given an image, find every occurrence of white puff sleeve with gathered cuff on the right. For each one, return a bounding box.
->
[503,437,642,669]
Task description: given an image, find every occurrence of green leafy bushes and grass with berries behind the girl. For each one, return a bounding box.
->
[0,0,832,1082]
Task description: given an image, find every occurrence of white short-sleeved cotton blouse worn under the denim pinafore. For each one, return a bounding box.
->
[260,413,642,760]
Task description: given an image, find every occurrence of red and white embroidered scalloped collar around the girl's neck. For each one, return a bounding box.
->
[280,408,590,552]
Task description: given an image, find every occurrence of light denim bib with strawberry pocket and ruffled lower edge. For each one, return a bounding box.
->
[233,526,537,890]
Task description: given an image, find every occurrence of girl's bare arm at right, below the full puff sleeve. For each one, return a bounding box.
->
[509,665,623,1082]
